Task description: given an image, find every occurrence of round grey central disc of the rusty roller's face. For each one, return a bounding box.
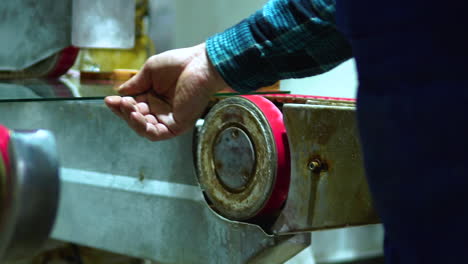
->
[213,127,255,191]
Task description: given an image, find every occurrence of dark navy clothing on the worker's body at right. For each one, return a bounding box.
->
[337,0,468,264]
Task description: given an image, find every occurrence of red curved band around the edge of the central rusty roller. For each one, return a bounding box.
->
[242,95,291,217]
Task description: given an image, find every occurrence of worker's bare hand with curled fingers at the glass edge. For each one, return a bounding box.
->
[105,44,227,141]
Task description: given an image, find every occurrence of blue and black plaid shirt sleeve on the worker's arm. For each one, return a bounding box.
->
[206,0,352,92]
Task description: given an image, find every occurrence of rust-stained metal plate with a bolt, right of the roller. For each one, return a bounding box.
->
[274,102,378,233]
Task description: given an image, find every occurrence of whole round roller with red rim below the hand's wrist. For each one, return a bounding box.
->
[197,95,290,220]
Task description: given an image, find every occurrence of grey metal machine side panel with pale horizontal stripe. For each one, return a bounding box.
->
[0,100,309,263]
